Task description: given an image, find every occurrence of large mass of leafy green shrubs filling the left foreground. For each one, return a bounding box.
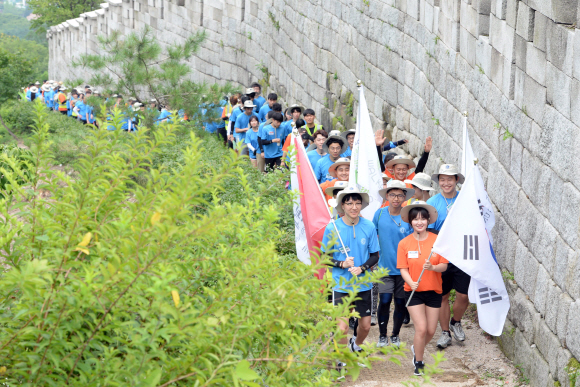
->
[0,103,416,386]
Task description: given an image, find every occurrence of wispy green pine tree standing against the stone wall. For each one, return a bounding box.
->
[73,27,235,120]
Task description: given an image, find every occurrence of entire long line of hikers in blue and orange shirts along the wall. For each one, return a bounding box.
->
[25,81,470,375]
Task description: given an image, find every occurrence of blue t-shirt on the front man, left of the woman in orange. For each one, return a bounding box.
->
[322,218,379,293]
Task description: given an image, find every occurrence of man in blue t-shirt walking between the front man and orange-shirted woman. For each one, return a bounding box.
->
[373,179,415,347]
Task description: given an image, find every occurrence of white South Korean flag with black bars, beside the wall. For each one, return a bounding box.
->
[433,166,510,336]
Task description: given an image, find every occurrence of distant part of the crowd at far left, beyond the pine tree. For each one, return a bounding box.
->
[23,80,176,132]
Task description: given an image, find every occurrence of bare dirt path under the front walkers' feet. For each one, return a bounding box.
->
[341,310,524,387]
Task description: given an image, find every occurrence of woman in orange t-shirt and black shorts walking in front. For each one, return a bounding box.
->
[397,201,449,376]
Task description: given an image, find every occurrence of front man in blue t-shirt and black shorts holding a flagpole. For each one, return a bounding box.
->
[321,187,379,368]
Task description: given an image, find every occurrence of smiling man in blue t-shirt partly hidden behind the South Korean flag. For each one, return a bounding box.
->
[427,164,471,349]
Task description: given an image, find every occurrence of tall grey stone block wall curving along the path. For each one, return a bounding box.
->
[48,0,580,387]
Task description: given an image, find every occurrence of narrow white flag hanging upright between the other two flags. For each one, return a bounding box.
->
[348,86,383,219]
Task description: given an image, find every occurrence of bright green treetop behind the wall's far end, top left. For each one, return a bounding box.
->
[28,0,101,32]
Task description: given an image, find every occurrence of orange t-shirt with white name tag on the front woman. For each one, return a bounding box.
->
[397,233,449,294]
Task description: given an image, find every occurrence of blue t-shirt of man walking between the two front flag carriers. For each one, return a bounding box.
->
[373,207,413,275]
